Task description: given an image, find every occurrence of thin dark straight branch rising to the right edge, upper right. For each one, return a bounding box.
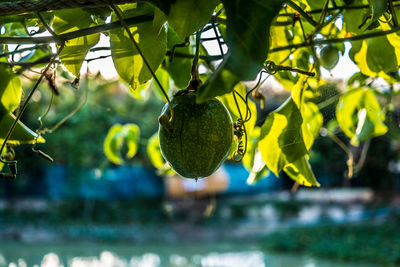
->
[269,26,400,53]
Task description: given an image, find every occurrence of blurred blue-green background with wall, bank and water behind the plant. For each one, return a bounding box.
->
[0,63,400,267]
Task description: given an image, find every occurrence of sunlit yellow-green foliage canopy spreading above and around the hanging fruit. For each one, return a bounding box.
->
[0,0,400,186]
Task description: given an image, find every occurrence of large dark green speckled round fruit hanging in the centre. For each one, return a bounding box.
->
[158,92,233,178]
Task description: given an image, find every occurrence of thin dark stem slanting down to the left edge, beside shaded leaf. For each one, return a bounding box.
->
[0,44,64,164]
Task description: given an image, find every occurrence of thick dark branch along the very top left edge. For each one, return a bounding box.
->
[0,0,145,16]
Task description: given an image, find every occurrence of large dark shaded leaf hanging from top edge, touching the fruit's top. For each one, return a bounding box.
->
[197,0,284,102]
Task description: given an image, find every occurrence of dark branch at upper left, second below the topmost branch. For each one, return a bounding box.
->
[0,15,154,44]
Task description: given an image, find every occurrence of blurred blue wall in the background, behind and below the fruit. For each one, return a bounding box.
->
[45,164,281,200]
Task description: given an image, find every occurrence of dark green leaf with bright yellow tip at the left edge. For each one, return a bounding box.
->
[0,112,45,145]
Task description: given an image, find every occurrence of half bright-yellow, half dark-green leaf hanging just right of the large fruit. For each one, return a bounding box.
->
[258,98,307,176]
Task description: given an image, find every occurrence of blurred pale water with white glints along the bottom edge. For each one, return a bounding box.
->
[0,242,378,267]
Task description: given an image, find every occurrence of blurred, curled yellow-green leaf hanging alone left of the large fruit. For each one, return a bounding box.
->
[103,123,140,165]
